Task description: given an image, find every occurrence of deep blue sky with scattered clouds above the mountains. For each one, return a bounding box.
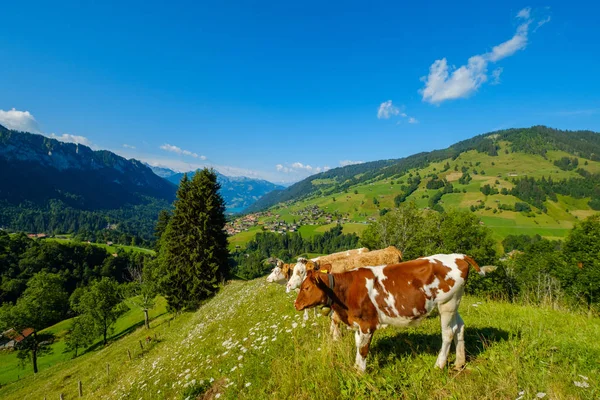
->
[0,1,600,182]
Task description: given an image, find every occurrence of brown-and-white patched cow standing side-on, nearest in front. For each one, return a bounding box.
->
[294,254,484,371]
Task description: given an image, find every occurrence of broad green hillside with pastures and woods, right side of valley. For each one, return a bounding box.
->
[232,127,600,245]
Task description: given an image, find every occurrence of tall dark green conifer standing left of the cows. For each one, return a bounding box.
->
[159,168,229,311]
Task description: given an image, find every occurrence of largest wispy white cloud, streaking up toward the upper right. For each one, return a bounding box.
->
[419,8,549,104]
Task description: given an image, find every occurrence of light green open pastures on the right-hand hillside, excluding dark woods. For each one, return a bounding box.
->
[230,142,600,246]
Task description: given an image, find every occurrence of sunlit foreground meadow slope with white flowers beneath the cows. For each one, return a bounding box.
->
[0,278,600,400]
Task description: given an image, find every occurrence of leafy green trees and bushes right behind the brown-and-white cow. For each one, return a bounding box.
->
[360,203,600,310]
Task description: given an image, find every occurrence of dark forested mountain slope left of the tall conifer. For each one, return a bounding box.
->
[0,126,176,242]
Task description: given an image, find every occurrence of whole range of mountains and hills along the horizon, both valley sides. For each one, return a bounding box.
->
[0,126,600,242]
